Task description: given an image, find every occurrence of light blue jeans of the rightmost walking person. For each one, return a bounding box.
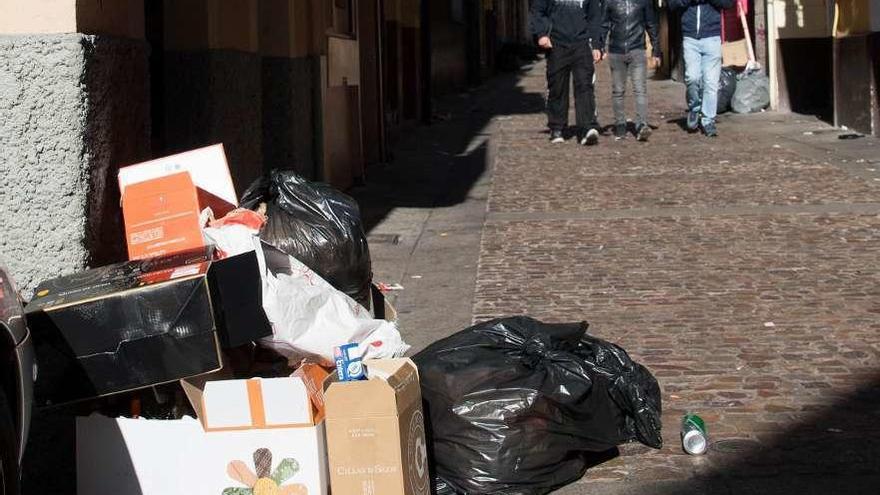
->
[684,36,721,126]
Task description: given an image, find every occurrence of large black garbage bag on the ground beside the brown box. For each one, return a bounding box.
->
[414,317,662,495]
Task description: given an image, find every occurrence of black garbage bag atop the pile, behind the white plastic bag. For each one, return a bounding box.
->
[241,170,373,307]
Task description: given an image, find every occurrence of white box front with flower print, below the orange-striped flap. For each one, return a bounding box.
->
[76,416,327,495]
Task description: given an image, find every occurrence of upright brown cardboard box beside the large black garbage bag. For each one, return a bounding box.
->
[324,359,430,495]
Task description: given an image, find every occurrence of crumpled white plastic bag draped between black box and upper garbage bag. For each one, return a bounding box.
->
[203,218,409,366]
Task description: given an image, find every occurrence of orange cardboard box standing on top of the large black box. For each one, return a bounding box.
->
[122,172,205,260]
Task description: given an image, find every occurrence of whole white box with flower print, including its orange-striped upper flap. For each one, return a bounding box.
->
[77,367,328,495]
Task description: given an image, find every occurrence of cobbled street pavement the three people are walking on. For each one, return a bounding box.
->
[356,59,880,494]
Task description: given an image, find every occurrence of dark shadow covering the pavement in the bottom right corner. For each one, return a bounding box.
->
[655,375,880,495]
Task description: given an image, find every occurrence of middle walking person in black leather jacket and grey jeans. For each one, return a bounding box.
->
[601,0,661,141]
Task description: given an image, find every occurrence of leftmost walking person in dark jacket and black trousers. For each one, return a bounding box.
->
[529,0,602,145]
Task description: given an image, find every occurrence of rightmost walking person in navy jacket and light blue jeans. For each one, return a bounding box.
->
[669,0,734,137]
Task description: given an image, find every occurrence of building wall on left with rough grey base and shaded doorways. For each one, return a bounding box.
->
[0,0,528,289]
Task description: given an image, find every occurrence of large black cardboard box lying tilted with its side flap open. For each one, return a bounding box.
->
[25,251,271,405]
